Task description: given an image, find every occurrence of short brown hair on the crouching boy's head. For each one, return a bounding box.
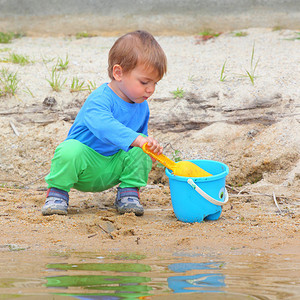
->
[108,30,167,79]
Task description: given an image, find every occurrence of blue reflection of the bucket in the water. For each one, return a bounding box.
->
[168,262,226,293]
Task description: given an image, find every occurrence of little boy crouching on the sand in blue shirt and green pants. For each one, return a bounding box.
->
[42,31,167,216]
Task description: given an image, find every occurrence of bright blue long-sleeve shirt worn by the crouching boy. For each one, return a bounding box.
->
[66,83,149,156]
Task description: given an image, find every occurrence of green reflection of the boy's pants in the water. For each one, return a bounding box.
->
[46,263,152,300]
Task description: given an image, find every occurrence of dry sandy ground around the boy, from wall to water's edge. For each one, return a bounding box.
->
[0,28,300,255]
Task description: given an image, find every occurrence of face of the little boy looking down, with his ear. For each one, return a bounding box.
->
[111,64,159,103]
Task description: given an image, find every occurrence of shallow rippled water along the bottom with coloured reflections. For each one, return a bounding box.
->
[0,251,300,300]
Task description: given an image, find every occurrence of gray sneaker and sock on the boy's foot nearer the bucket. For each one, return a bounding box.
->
[115,188,144,216]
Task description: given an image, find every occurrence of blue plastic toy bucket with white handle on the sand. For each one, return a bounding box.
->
[166,160,229,223]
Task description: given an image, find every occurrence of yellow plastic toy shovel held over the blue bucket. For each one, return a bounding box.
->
[142,143,212,177]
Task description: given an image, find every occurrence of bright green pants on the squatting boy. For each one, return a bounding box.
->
[45,140,152,192]
